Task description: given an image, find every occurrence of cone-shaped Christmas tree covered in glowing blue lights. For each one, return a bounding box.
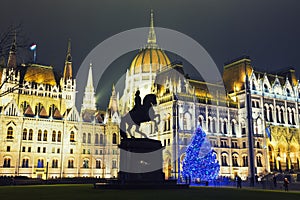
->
[182,126,220,181]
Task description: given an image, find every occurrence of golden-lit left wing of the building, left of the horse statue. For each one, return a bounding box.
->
[0,38,119,179]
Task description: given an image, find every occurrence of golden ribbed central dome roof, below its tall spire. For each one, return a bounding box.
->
[130,47,170,74]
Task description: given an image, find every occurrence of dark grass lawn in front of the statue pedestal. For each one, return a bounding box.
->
[0,185,300,200]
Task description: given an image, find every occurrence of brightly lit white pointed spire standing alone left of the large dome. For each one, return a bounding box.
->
[81,63,97,111]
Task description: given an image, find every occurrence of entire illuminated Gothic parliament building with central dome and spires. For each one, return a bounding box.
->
[0,12,300,179]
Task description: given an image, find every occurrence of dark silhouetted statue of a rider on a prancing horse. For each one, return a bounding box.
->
[120,91,160,139]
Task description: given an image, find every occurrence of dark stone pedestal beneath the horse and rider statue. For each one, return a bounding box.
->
[119,138,164,184]
